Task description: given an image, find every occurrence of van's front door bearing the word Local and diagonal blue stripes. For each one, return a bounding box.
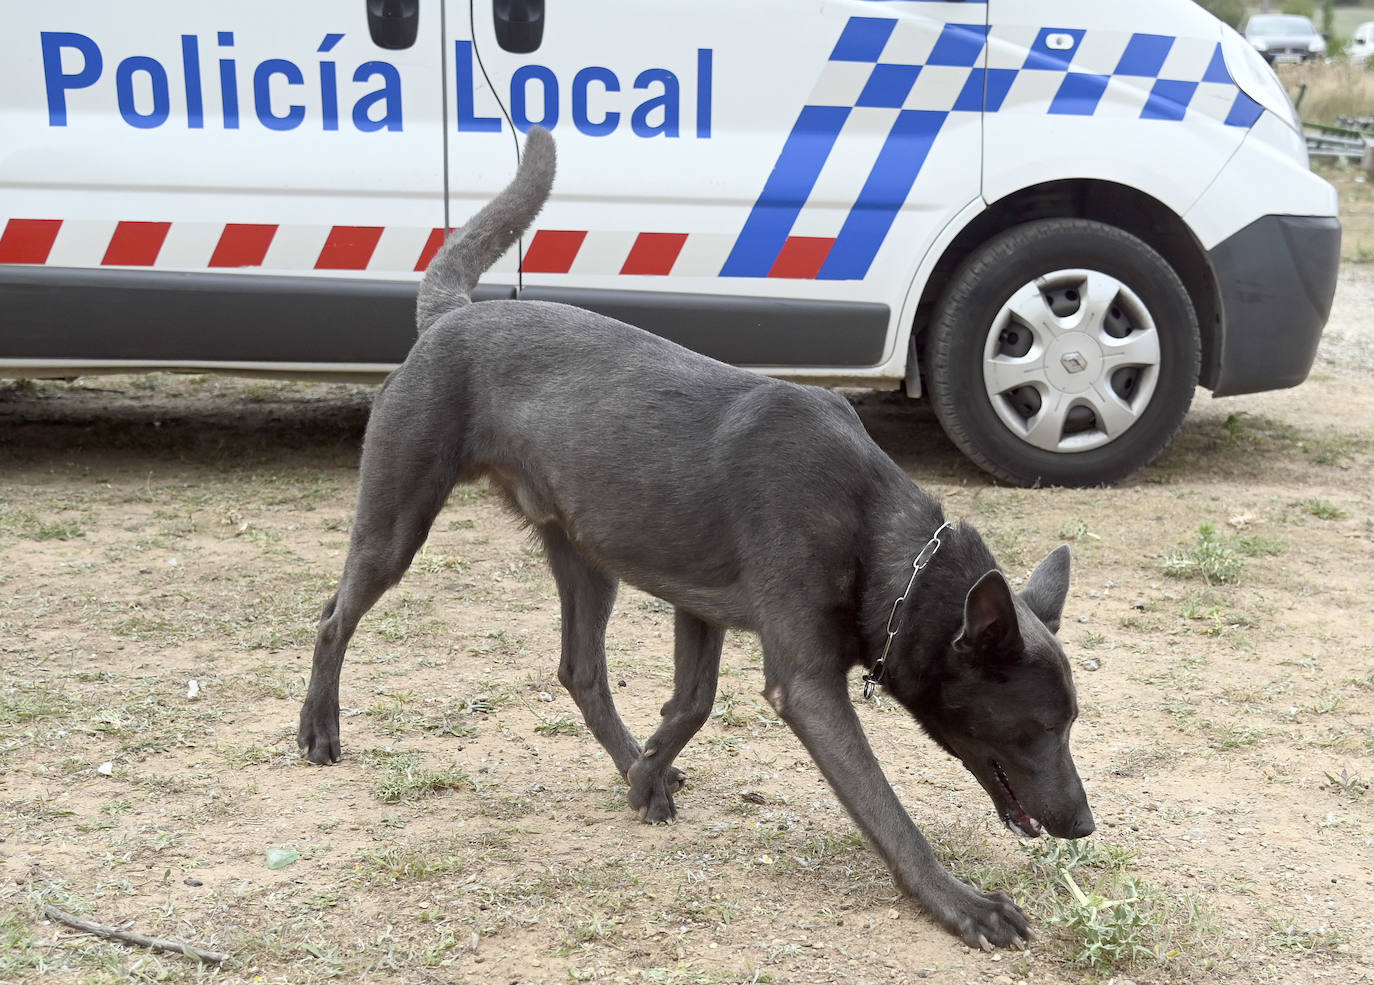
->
[449,0,987,376]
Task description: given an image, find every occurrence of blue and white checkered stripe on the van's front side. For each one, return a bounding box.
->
[720,16,1263,280]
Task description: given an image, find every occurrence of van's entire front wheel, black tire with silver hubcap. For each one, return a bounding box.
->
[922,218,1201,486]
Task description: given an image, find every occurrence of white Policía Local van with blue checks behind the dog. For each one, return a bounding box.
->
[0,0,1340,484]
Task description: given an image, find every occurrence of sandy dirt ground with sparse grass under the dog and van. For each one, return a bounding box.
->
[8,264,1374,985]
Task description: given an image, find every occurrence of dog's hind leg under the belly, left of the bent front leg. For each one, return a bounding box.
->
[539,523,639,776]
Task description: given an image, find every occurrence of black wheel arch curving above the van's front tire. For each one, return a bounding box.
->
[911,179,1224,389]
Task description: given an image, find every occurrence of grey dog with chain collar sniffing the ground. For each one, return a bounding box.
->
[298,129,1092,948]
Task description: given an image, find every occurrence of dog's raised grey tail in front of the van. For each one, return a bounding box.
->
[415,126,555,332]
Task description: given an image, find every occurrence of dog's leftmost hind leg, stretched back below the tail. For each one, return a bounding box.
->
[295,379,458,765]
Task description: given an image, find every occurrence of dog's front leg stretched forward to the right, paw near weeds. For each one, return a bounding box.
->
[764,648,1031,949]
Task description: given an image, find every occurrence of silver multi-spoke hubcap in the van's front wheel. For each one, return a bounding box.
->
[982,271,1160,452]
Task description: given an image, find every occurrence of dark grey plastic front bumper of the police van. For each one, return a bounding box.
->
[1208,216,1341,397]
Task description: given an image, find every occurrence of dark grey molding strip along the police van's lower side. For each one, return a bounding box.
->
[0,264,888,375]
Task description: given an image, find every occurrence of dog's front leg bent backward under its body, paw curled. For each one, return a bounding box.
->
[627,609,725,824]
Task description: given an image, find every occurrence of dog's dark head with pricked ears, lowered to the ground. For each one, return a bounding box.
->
[914,547,1094,838]
